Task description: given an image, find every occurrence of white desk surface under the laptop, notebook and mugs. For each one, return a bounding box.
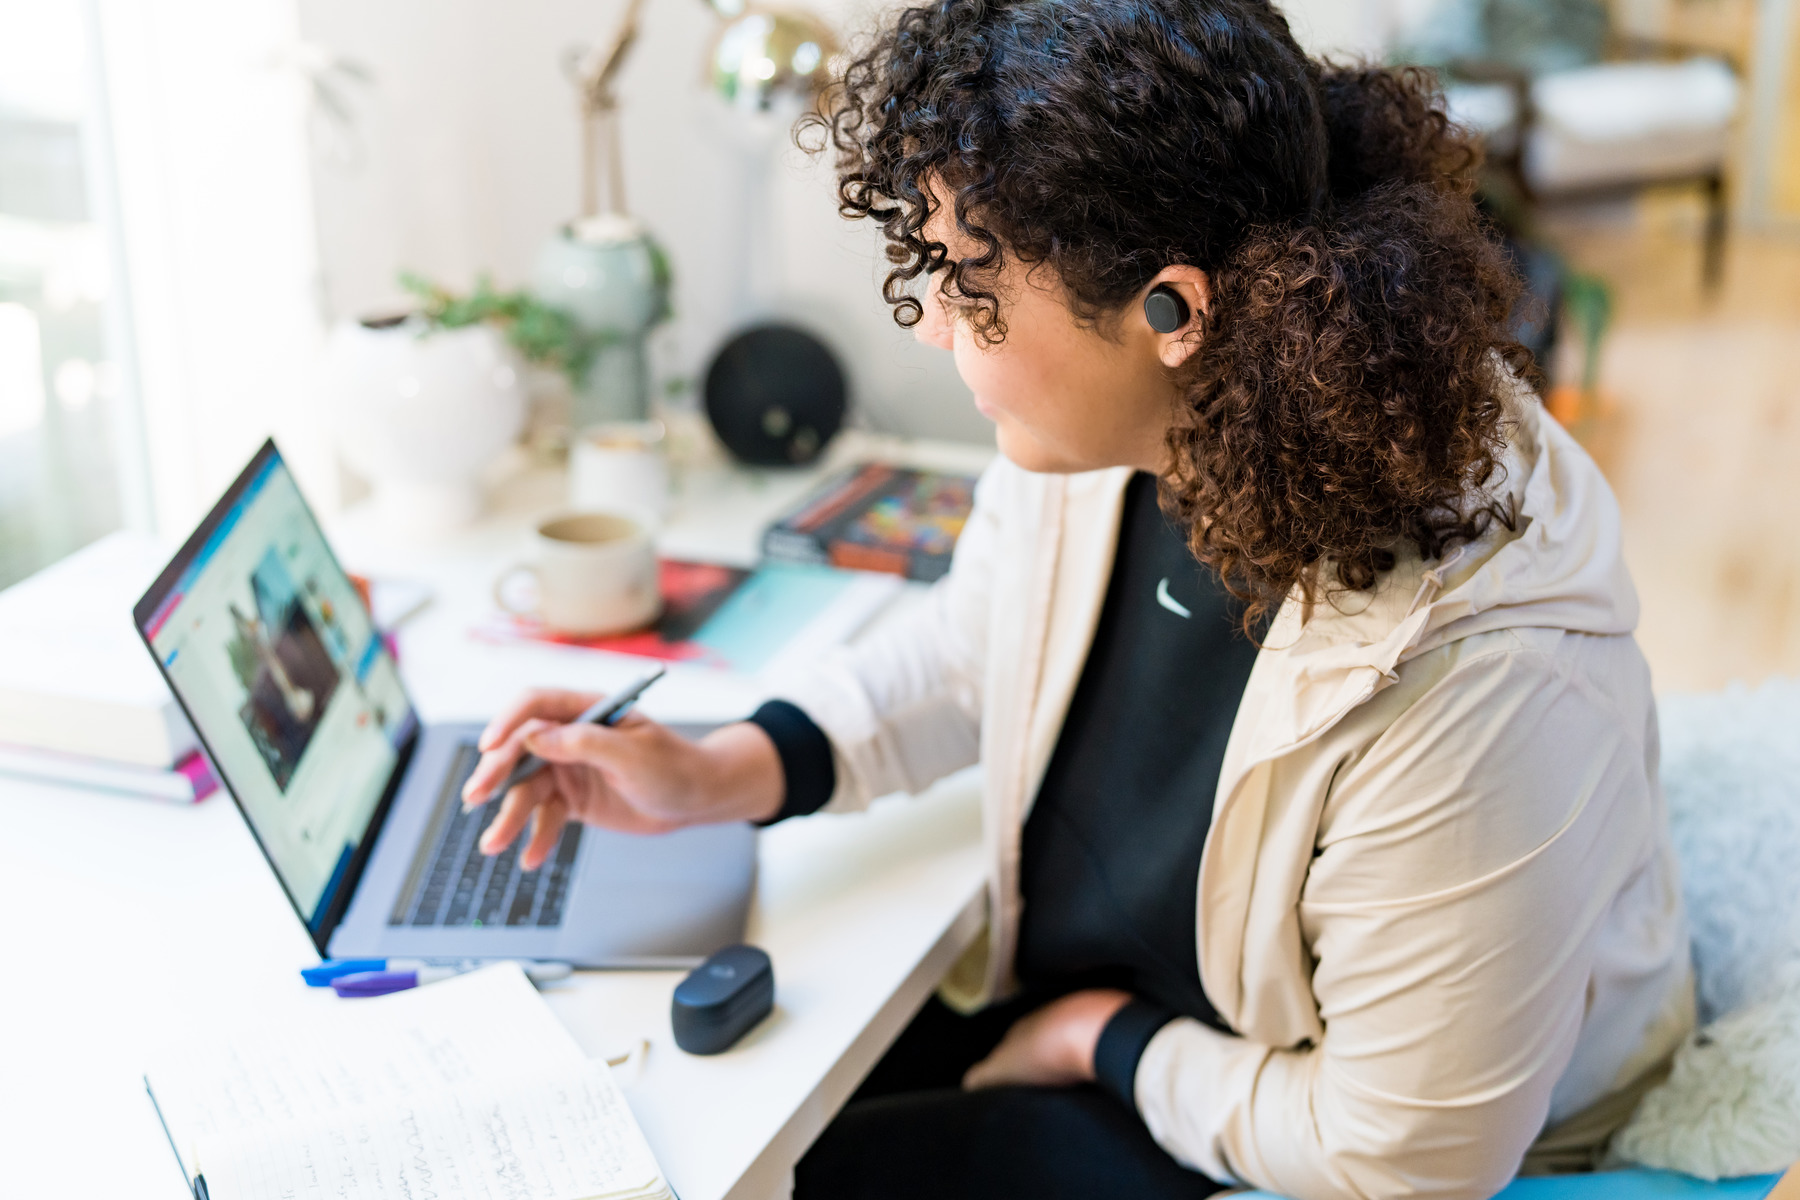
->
[0,443,985,1200]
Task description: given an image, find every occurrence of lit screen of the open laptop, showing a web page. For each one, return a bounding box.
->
[139,443,416,934]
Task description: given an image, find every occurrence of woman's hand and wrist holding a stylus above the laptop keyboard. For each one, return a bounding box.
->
[463,691,787,871]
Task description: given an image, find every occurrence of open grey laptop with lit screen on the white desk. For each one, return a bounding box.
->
[133,441,756,966]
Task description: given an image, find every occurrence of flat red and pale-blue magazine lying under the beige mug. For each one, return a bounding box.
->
[475,560,902,675]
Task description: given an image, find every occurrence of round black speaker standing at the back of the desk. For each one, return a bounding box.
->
[706,326,846,466]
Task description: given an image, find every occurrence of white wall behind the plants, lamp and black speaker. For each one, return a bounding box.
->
[299,0,992,441]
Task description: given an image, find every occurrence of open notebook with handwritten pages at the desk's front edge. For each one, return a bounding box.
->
[144,963,671,1200]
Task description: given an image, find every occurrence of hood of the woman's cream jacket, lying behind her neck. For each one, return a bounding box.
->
[1264,395,1638,741]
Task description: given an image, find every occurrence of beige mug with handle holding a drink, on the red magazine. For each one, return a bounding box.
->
[493,513,662,637]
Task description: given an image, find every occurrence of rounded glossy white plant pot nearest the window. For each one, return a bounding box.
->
[319,317,526,533]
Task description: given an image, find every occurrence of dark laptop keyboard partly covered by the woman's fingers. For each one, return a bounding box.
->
[387,743,581,928]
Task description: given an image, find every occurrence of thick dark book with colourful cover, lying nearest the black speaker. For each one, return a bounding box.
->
[763,462,976,583]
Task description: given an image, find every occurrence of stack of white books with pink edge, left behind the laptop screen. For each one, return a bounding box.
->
[0,533,218,802]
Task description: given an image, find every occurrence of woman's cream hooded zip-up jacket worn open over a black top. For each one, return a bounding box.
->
[783,398,1694,1200]
